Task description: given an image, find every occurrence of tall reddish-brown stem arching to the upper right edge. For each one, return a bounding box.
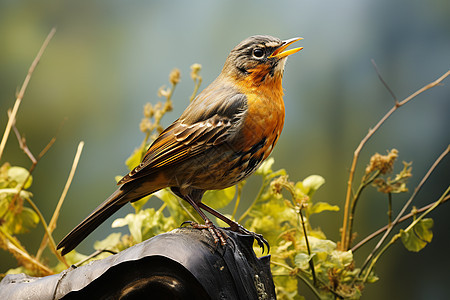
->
[340,71,450,250]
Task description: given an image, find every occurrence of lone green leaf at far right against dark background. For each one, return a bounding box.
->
[401,218,434,252]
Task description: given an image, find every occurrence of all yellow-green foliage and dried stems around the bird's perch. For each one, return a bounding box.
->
[0,31,450,299]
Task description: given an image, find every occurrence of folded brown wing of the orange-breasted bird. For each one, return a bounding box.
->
[118,89,247,184]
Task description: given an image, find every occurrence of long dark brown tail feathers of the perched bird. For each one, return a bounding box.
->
[56,184,141,255]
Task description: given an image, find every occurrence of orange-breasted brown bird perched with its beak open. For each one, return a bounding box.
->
[57,35,303,255]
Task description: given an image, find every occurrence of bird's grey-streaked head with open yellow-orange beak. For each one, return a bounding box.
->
[222,35,303,88]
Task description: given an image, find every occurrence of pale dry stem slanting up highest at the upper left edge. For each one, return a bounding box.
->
[0,28,56,158]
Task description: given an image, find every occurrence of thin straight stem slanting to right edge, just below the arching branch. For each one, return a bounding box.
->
[359,145,450,274]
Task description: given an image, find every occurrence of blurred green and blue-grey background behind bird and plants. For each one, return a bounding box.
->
[0,0,450,299]
